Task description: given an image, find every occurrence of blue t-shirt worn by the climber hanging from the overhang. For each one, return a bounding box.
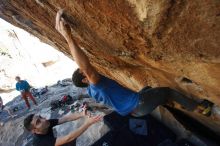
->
[87,76,139,116]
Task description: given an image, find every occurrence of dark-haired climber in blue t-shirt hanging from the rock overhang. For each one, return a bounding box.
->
[56,10,213,116]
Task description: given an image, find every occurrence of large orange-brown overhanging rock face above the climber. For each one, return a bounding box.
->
[0,0,220,132]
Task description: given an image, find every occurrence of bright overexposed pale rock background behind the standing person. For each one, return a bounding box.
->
[0,19,77,104]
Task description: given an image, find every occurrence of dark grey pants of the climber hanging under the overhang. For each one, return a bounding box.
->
[132,87,198,117]
